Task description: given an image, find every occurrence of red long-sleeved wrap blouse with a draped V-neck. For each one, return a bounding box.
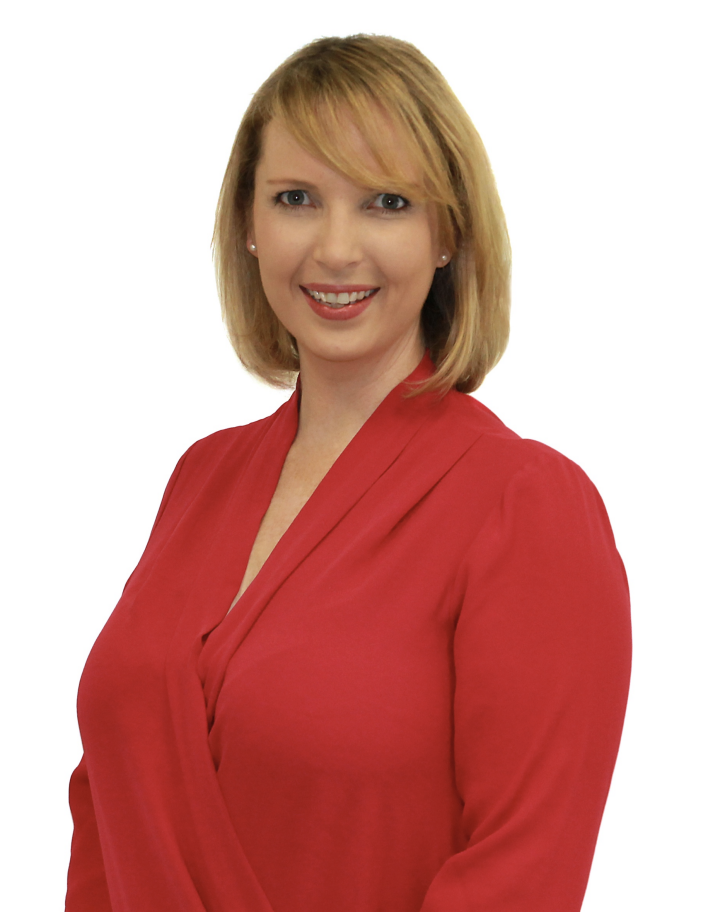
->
[66,354,631,911]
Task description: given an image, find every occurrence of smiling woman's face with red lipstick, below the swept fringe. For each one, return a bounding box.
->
[248,119,448,367]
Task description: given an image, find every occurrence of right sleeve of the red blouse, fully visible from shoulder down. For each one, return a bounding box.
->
[421,444,632,912]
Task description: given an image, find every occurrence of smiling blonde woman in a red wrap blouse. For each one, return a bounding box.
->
[66,36,631,911]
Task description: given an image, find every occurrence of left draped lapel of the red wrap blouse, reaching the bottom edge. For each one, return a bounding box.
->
[157,391,298,911]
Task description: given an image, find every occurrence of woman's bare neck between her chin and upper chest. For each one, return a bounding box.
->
[295,337,424,451]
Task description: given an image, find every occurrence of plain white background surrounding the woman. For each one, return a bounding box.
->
[0,0,706,916]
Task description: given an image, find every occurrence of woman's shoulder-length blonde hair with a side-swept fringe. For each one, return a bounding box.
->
[212,35,511,394]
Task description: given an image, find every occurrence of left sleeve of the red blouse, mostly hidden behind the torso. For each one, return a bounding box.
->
[65,447,192,912]
